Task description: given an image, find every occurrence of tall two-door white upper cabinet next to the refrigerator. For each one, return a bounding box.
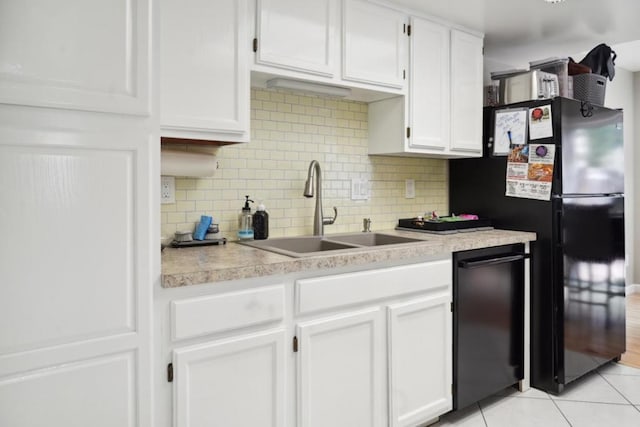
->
[369,17,483,158]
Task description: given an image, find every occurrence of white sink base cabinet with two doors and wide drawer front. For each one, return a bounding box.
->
[295,259,452,427]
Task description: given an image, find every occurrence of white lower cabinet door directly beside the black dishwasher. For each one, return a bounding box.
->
[388,292,452,427]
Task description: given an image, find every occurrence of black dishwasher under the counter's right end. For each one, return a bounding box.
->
[452,243,528,410]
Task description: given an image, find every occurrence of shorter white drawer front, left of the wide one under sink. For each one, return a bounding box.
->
[171,285,284,341]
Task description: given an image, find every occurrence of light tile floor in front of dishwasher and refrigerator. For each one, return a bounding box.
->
[433,363,640,427]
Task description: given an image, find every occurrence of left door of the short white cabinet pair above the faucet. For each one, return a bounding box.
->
[256,0,338,77]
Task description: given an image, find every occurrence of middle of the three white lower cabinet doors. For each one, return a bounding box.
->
[297,308,385,427]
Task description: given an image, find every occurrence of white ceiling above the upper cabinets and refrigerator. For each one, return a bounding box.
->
[393,0,640,71]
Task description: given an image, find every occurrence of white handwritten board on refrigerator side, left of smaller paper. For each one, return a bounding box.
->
[493,108,528,156]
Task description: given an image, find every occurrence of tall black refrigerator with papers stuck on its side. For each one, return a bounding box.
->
[449,98,625,394]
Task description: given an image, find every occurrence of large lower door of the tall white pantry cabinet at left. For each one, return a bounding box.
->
[0,117,155,427]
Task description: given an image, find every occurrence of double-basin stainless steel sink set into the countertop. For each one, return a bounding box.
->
[240,233,424,258]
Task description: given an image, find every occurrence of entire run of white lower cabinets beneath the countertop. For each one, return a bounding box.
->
[166,257,452,427]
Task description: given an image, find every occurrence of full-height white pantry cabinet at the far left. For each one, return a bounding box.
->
[0,0,155,427]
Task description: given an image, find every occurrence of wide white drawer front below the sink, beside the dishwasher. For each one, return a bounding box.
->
[295,258,452,314]
